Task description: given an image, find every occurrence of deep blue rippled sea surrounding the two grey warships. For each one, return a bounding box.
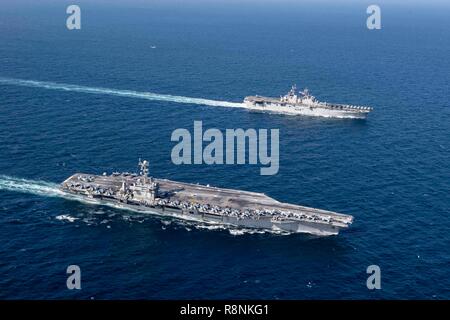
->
[0,0,450,299]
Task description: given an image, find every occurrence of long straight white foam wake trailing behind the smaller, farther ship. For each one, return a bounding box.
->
[0,77,244,108]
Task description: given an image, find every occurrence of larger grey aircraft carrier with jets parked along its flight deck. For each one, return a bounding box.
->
[61,160,353,236]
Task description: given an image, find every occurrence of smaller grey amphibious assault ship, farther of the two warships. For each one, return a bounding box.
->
[244,85,373,119]
